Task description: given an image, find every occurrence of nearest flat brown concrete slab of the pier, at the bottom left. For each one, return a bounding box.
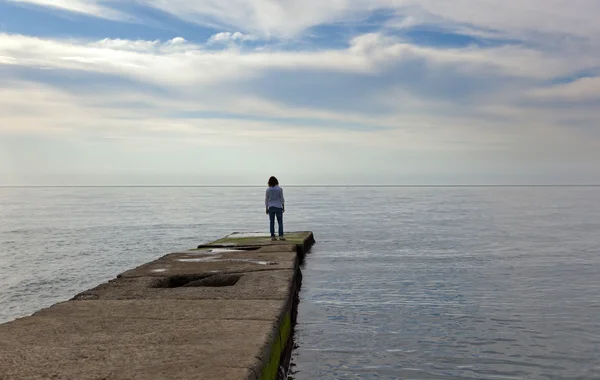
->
[0,316,278,379]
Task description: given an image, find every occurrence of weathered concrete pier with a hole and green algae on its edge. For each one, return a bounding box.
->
[0,232,314,380]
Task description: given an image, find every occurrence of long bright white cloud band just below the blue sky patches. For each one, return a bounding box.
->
[0,34,588,91]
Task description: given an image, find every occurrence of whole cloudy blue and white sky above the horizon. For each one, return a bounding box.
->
[0,0,600,186]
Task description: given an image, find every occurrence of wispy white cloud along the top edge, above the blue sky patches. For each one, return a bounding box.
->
[9,0,600,44]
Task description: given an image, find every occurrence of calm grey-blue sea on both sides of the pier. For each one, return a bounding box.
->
[0,187,600,380]
